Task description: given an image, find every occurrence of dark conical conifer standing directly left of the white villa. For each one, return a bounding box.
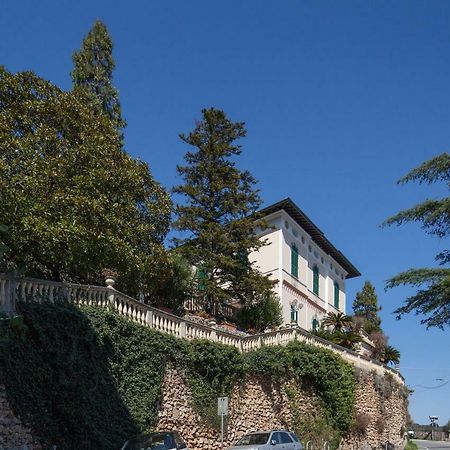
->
[174,108,274,309]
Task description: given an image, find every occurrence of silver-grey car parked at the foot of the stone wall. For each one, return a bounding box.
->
[228,430,303,450]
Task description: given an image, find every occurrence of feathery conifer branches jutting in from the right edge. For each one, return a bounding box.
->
[383,153,450,329]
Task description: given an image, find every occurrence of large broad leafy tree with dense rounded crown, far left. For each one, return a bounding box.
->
[0,69,171,294]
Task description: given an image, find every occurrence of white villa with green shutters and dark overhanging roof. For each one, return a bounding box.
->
[249,198,361,330]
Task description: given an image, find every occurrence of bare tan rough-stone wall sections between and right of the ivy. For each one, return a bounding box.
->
[157,365,407,450]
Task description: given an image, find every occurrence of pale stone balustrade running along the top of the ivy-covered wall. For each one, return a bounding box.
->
[0,273,404,383]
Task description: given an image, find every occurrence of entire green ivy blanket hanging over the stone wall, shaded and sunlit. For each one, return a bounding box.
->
[0,303,356,450]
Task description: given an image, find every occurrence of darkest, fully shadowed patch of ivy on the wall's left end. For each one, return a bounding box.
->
[0,304,141,450]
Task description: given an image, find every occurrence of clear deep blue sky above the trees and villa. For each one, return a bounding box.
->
[0,0,450,423]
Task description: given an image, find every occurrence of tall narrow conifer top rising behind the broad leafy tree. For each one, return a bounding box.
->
[71,20,125,134]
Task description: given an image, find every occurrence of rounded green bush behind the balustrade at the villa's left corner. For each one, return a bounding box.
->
[237,293,283,332]
